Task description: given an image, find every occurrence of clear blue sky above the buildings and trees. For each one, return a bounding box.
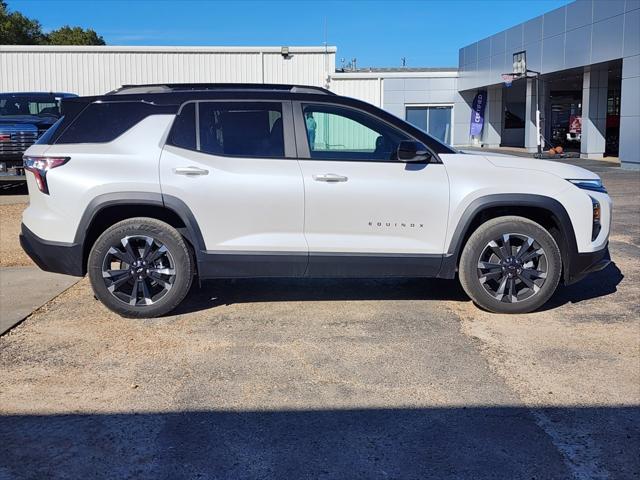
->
[8,0,569,67]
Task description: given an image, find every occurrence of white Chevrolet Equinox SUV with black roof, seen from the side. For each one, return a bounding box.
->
[21,84,611,317]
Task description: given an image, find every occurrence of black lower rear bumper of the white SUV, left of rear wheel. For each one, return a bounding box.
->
[20,224,85,277]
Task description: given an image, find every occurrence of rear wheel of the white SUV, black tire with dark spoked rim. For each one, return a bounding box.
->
[87,217,194,318]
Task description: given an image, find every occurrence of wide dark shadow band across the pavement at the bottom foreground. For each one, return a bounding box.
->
[0,405,640,480]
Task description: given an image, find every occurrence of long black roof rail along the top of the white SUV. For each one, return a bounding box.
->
[105,83,335,95]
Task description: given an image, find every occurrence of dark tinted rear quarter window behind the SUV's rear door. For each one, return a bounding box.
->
[55,102,175,144]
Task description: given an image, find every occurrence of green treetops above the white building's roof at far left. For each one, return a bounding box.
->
[0,0,105,45]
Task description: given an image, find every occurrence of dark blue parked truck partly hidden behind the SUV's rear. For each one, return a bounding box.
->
[0,92,76,181]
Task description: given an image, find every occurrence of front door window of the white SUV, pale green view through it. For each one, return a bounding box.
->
[303,105,409,161]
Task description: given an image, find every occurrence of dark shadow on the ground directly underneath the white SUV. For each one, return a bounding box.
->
[171,263,624,315]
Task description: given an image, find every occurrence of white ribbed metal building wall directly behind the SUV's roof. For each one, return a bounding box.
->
[0,45,336,95]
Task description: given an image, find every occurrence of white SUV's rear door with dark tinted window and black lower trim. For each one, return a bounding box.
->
[160,100,308,277]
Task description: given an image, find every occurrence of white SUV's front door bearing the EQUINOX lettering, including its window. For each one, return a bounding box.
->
[294,103,449,276]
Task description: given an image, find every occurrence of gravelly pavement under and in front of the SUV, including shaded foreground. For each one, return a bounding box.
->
[0,163,640,480]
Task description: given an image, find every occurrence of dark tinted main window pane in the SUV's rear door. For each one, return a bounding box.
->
[197,102,284,157]
